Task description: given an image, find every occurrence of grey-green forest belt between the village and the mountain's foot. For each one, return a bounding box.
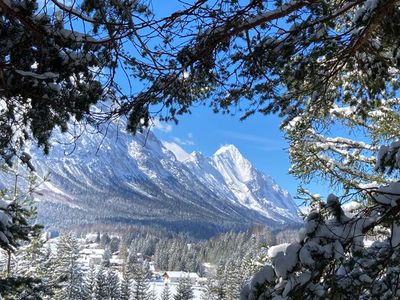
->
[91,225,297,275]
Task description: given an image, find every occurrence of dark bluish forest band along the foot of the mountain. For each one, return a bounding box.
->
[37,197,247,239]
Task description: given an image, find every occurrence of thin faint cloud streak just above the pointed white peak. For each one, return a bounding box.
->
[218,130,286,151]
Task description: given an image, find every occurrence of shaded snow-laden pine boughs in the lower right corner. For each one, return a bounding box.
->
[240,183,400,300]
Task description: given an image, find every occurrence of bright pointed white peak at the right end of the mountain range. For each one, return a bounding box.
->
[184,145,298,222]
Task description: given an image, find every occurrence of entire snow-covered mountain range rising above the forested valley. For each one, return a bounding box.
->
[25,121,299,236]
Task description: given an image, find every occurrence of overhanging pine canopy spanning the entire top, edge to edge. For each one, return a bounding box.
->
[0,0,400,160]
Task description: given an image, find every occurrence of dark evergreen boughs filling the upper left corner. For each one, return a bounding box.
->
[0,0,156,162]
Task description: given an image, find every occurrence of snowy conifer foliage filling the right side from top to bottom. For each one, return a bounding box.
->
[222,0,400,299]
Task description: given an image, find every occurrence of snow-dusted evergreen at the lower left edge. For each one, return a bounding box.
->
[0,168,48,299]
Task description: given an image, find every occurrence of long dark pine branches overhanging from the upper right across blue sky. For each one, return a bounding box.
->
[76,0,400,143]
